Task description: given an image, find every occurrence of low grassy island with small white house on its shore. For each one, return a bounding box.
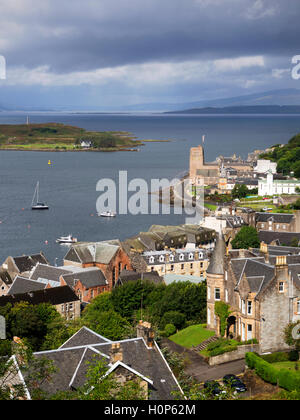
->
[0,123,142,150]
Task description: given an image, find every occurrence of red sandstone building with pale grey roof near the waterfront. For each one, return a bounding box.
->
[64,240,132,291]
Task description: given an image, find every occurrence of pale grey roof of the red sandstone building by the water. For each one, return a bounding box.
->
[64,240,121,264]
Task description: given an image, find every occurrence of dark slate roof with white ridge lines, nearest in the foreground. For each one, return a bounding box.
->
[28,327,181,400]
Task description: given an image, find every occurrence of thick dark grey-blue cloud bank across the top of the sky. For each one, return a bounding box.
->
[0,0,300,73]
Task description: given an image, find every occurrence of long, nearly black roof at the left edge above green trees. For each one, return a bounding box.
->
[0,286,79,306]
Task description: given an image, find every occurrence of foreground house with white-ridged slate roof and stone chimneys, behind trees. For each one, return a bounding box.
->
[9,321,183,401]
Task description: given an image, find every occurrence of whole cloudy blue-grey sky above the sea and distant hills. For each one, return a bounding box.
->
[0,0,300,109]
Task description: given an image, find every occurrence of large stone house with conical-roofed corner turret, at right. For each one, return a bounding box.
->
[207,237,300,352]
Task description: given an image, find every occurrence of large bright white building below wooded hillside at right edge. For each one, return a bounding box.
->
[258,171,300,196]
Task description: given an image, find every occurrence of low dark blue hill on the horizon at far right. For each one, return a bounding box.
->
[166,105,300,114]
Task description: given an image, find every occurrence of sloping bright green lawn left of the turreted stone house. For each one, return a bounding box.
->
[169,324,215,349]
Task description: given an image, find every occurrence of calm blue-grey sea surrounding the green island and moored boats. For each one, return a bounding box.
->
[0,113,300,264]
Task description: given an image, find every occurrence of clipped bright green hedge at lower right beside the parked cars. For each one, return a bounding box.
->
[246,353,300,391]
